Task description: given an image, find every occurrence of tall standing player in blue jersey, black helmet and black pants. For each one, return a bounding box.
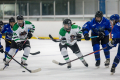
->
[82,11,111,68]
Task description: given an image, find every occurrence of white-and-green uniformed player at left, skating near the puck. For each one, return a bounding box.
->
[5,15,35,66]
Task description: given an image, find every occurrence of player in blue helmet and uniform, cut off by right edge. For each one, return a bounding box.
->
[107,14,120,74]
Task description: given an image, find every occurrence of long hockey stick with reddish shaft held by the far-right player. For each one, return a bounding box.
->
[52,47,107,66]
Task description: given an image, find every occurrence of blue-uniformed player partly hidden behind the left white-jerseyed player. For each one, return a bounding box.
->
[1,17,15,62]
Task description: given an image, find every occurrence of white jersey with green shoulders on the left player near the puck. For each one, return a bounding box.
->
[12,21,35,42]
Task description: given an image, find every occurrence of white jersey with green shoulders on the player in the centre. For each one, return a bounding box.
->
[59,25,82,45]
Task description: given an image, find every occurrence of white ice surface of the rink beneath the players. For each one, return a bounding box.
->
[0,39,120,80]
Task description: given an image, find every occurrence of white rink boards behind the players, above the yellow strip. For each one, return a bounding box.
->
[32,21,86,37]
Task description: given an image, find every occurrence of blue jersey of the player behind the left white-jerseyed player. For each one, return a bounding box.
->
[2,24,13,40]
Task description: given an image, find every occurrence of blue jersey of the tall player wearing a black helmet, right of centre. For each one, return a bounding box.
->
[82,17,111,36]
